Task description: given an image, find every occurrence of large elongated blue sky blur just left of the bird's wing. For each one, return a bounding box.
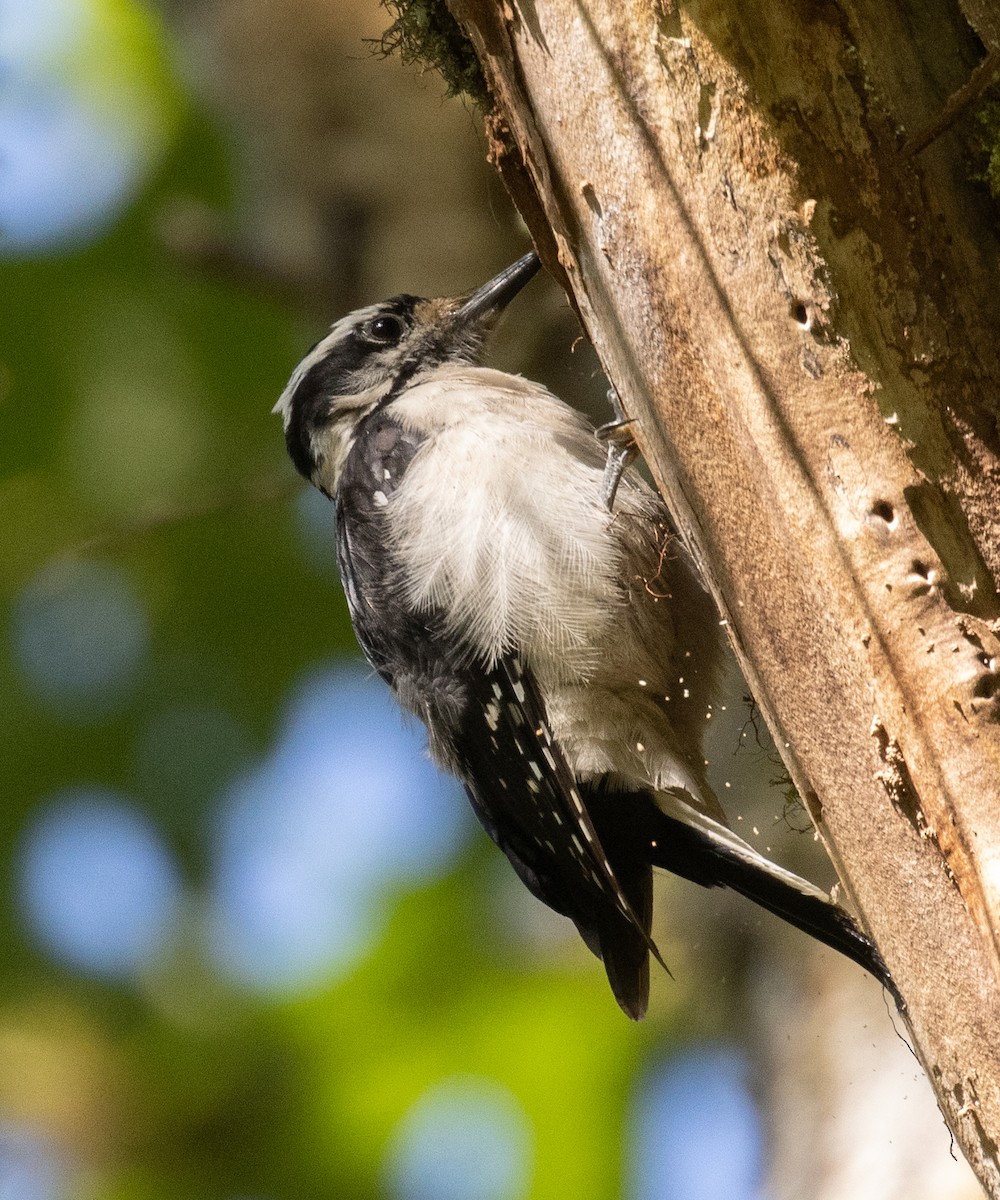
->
[211,664,472,991]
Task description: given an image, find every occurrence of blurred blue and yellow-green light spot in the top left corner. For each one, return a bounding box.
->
[0,0,179,257]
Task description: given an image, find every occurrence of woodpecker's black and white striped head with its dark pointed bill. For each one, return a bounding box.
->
[274,251,541,492]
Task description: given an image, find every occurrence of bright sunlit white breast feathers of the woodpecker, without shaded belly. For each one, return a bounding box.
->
[390,367,624,678]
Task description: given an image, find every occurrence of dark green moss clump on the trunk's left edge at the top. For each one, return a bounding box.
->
[376,0,492,110]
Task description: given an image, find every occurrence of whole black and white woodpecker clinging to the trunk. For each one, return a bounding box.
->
[275,253,896,1019]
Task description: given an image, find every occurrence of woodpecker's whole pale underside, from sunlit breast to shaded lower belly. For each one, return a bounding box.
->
[389,366,725,822]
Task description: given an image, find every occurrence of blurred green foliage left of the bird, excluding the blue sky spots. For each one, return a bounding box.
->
[0,5,705,1200]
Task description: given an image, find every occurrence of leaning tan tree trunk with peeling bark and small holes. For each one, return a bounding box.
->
[450,0,1000,1196]
